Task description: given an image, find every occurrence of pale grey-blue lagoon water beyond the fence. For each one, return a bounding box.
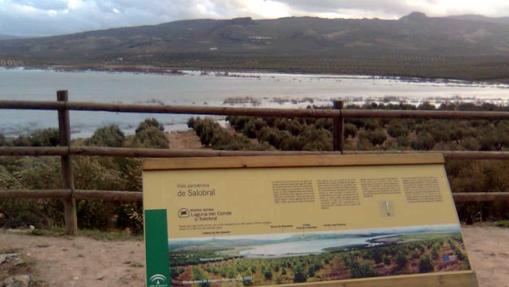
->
[0,69,509,138]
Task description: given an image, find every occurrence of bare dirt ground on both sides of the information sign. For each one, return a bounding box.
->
[0,226,509,287]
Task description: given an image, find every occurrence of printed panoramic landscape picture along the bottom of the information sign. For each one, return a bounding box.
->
[168,224,470,286]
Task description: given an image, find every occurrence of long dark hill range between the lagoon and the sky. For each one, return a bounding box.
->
[0,12,509,79]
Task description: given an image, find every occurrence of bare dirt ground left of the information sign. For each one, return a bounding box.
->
[0,232,145,287]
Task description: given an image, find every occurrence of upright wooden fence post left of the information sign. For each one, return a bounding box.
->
[57,91,78,235]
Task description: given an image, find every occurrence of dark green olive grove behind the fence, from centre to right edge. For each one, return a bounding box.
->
[189,102,509,222]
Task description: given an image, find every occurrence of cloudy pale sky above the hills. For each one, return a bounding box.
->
[0,0,509,36]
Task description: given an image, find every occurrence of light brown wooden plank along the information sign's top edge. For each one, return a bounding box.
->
[143,153,444,171]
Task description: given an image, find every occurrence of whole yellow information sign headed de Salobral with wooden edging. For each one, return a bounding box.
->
[143,154,477,287]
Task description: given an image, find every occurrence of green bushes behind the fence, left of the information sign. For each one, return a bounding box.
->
[0,119,169,233]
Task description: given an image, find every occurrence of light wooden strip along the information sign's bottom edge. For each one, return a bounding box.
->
[274,271,478,287]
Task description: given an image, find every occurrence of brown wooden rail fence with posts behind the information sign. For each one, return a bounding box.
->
[0,91,509,235]
